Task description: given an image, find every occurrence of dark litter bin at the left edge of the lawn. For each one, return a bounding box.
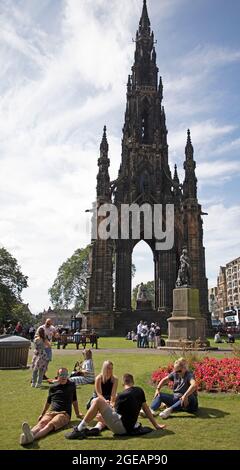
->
[0,335,31,369]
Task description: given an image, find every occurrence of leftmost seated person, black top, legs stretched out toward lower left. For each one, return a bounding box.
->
[20,368,83,446]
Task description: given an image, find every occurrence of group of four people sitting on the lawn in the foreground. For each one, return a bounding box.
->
[20,358,198,446]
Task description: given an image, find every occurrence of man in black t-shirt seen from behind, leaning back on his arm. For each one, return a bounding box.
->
[65,374,165,439]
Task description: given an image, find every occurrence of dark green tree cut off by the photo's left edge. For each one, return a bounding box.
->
[0,248,28,324]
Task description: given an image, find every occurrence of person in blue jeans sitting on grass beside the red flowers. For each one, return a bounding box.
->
[144,357,198,419]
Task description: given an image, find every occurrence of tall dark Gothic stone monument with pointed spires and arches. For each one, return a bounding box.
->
[85,0,210,333]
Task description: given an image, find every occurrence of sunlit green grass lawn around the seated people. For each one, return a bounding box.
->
[0,344,240,450]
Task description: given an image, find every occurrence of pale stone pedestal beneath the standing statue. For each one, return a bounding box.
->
[166,287,208,348]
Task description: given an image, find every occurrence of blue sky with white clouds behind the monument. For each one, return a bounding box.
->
[0,0,240,313]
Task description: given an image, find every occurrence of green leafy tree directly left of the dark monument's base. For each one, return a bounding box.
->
[49,245,90,312]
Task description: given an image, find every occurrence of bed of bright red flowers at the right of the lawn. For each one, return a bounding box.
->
[152,357,240,392]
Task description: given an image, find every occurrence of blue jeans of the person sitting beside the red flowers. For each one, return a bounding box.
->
[150,393,198,413]
